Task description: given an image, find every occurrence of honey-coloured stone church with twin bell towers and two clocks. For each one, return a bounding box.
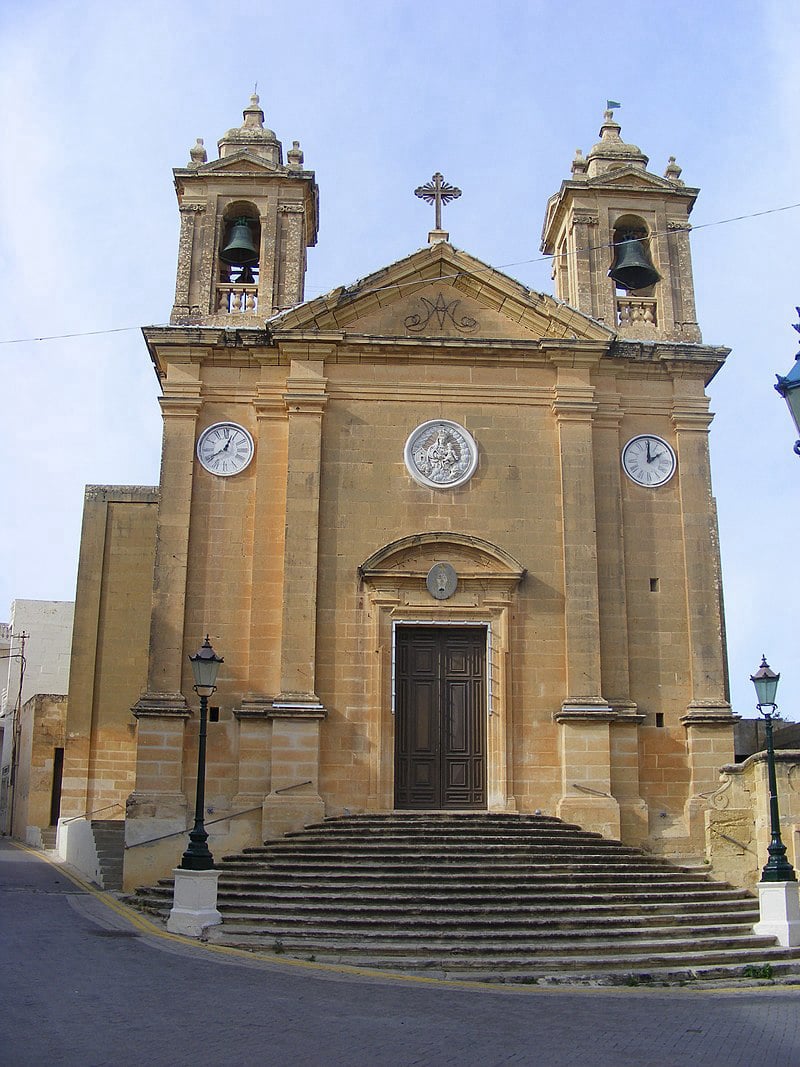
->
[62,96,735,886]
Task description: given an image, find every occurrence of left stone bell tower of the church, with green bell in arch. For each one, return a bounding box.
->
[170,94,319,328]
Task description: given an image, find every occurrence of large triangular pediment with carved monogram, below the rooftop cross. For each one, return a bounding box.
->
[270,241,613,341]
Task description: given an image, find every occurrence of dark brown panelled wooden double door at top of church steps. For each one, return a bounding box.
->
[395,626,486,810]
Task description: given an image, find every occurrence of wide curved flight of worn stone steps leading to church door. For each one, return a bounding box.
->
[129,812,800,984]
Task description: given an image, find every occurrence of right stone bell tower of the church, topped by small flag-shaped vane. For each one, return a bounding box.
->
[542,111,702,343]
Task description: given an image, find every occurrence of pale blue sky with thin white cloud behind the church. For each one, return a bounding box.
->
[0,0,800,718]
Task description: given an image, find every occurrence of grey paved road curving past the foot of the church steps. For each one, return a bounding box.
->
[0,840,800,1067]
